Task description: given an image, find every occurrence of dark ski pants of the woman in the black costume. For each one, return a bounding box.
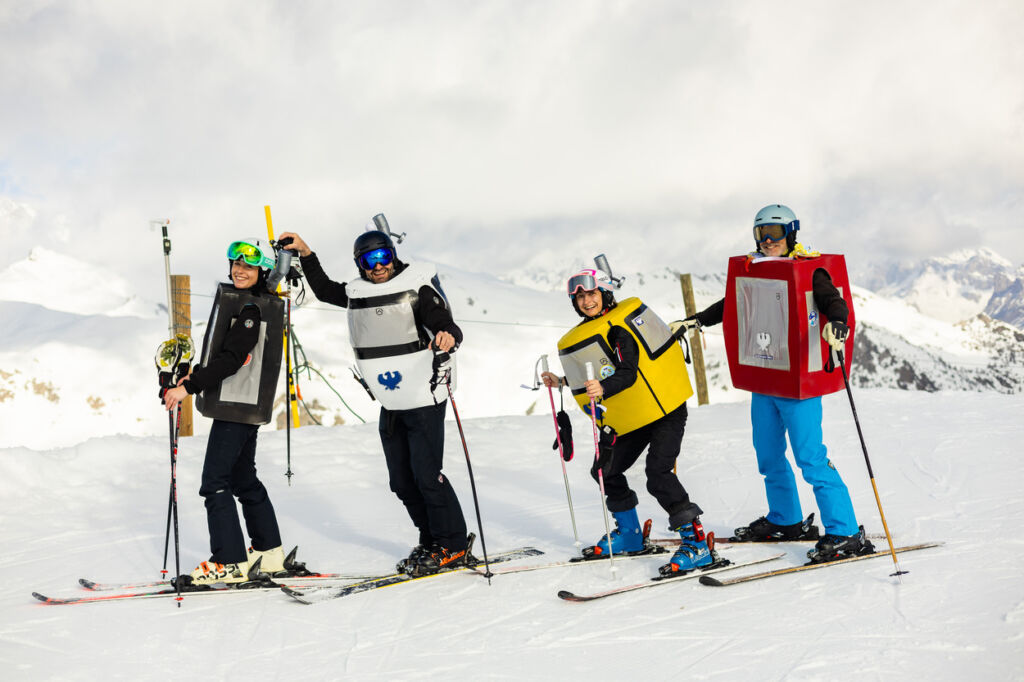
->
[199,419,281,563]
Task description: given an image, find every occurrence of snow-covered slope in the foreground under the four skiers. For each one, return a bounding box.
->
[0,389,1024,680]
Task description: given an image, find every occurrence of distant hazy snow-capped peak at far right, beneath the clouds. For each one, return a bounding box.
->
[857,249,1024,329]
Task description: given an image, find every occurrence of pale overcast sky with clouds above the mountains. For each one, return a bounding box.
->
[0,0,1024,299]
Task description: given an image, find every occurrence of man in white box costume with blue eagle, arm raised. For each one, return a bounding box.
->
[281,216,468,576]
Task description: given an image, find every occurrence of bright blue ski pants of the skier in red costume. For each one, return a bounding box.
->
[751,393,857,536]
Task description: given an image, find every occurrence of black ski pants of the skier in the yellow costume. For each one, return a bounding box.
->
[590,402,702,528]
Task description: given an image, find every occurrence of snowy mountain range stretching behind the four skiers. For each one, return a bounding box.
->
[0,249,1024,447]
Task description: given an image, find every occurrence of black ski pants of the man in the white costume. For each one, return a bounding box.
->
[379,400,466,551]
